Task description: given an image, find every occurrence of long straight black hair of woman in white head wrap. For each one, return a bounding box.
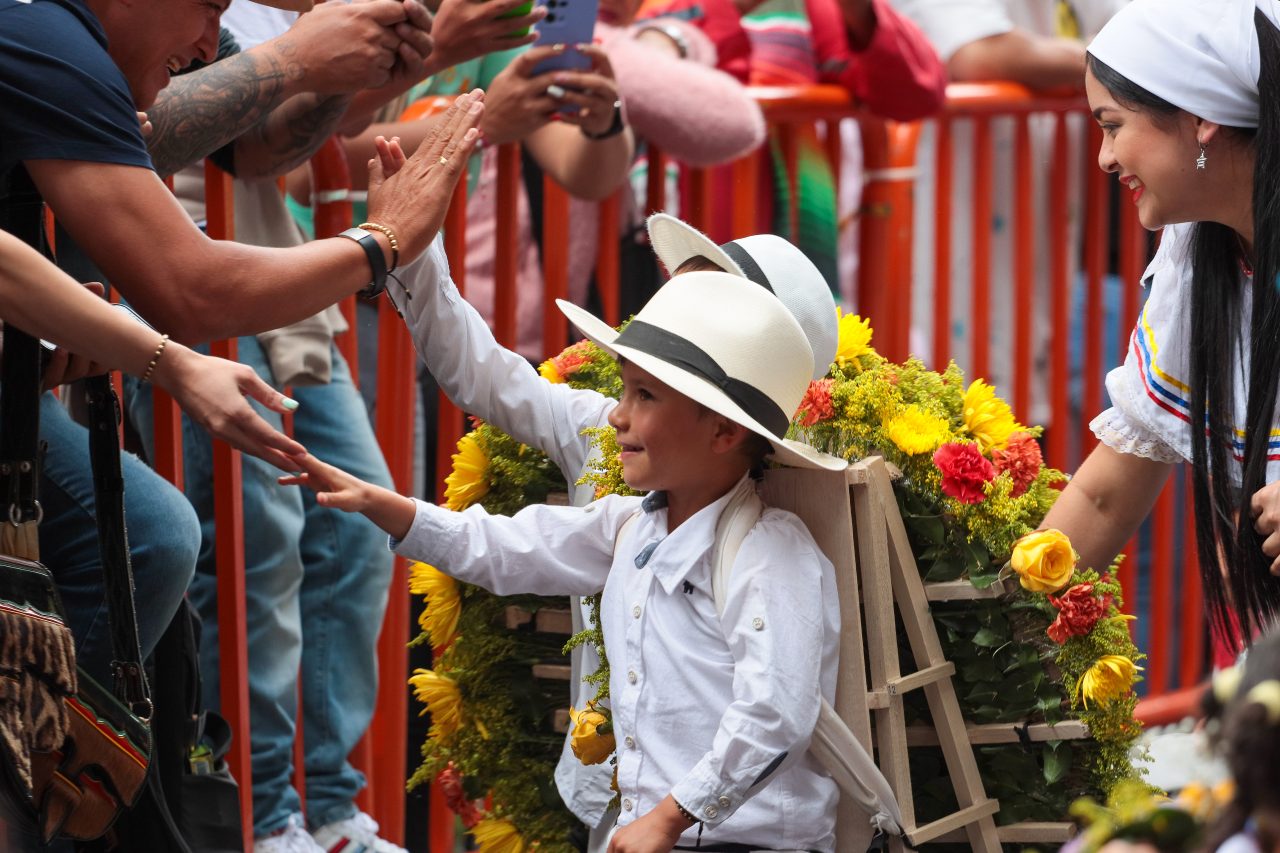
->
[1088,12,1280,644]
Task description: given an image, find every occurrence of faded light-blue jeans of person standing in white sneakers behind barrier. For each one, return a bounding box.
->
[129,337,392,836]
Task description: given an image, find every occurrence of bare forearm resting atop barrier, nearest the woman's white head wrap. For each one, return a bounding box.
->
[947,28,1084,88]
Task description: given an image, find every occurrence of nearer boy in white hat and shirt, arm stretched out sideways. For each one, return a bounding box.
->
[282,273,845,852]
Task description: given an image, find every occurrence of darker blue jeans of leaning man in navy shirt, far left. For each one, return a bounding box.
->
[40,393,200,688]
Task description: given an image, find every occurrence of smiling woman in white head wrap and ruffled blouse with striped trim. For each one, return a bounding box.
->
[1044,0,1280,653]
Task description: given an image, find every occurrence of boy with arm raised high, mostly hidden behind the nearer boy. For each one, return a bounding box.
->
[373,208,837,852]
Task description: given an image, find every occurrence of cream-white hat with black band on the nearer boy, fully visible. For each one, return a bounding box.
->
[556,273,849,471]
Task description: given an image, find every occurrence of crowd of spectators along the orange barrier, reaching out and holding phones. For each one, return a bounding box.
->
[0,0,1121,853]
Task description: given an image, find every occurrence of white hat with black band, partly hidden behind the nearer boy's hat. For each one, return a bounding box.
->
[648,214,840,379]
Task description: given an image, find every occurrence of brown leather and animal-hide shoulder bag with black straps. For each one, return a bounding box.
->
[0,168,151,843]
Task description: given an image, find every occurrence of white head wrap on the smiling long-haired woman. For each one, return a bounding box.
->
[1089,0,1280,127]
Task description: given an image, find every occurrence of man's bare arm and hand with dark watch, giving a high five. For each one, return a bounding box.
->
[26,96,483,342]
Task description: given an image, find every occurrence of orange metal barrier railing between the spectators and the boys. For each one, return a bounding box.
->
[145,83,1204,850]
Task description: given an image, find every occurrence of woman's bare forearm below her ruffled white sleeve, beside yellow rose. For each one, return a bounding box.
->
[1041,444,1174,571]
